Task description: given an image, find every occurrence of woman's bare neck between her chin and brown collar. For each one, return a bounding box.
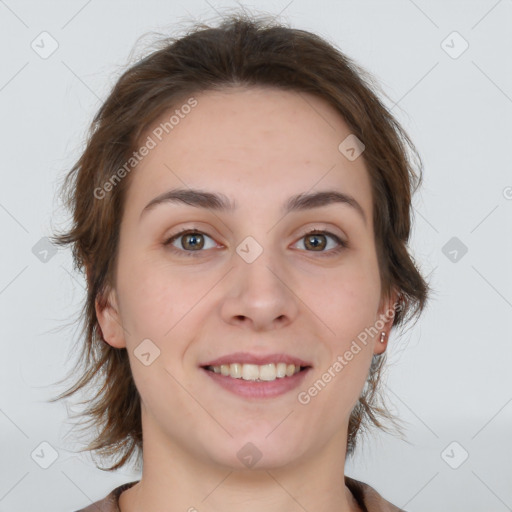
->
[119,418,360,512]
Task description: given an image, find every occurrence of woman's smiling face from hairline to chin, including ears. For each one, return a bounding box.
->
[97,88,398,468]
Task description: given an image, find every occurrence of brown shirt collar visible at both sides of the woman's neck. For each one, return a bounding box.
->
[76,475,405,512]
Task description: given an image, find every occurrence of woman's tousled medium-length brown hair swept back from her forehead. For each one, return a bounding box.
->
[51,13,429,471]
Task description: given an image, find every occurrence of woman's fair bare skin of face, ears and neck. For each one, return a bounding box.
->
[96,88,396,512]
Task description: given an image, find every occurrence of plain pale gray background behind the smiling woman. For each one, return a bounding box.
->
[0,0,512,512]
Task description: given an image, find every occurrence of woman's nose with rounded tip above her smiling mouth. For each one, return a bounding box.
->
[221,251,299,331]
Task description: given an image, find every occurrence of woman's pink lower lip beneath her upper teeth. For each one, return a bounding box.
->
[202,368,310,398]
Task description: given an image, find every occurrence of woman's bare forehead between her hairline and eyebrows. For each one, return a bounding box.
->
[124,87,371,222]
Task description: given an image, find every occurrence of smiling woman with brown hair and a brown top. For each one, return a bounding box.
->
[55,15,428,512]
